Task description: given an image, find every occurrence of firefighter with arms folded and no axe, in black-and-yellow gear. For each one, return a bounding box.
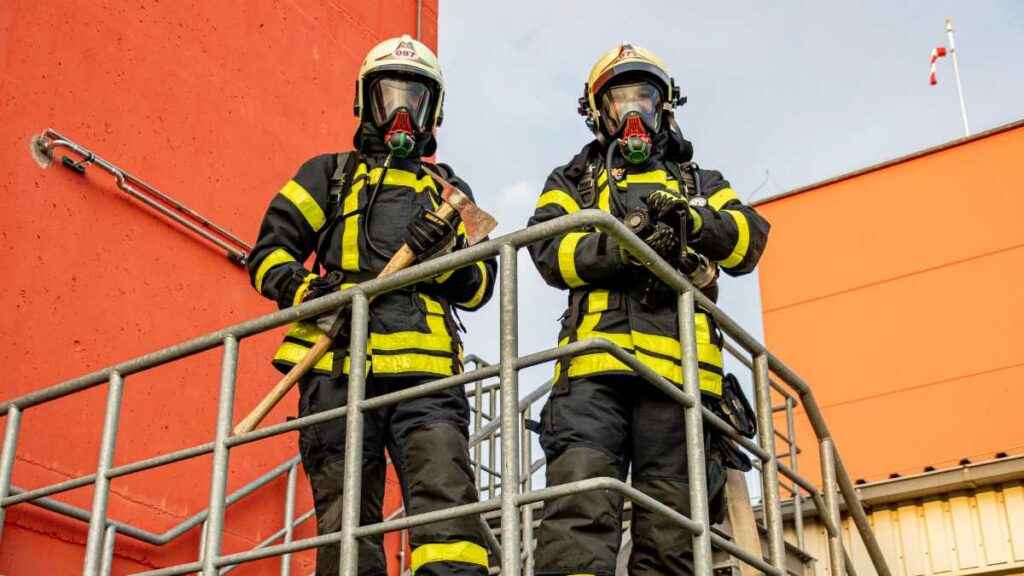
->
[529,44,769,576]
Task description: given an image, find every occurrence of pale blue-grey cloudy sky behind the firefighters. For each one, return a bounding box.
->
[438,0,1024,389]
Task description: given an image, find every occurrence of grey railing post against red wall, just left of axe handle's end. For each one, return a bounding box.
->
[203,336,239,576]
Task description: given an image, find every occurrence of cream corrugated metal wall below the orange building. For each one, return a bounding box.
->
[786,482,1024,576]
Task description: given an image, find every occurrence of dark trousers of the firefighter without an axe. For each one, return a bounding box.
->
[536,376,725,576]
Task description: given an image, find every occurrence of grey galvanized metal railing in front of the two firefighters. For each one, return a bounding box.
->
[0,209,890,576]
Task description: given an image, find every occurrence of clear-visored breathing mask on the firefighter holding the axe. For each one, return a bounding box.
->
[370,78,431,158]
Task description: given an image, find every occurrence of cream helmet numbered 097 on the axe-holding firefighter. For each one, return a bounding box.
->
[353,34,444,133]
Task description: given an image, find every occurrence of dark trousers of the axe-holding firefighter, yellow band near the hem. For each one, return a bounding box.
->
[299,373,487,576]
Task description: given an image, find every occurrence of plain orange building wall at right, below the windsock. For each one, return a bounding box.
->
[759,126,1024,480]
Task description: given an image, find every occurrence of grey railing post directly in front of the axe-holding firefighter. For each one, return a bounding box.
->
[337,292,370,576]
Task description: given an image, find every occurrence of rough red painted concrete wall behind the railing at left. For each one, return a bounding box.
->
[0,0,437,575]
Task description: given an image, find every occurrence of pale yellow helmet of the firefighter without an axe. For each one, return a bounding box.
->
[578,42,685,134]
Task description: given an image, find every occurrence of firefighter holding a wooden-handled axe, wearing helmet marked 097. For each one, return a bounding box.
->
[249,36,497,576]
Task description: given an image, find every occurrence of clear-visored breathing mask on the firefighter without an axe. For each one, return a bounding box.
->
[601,82,664,164]
